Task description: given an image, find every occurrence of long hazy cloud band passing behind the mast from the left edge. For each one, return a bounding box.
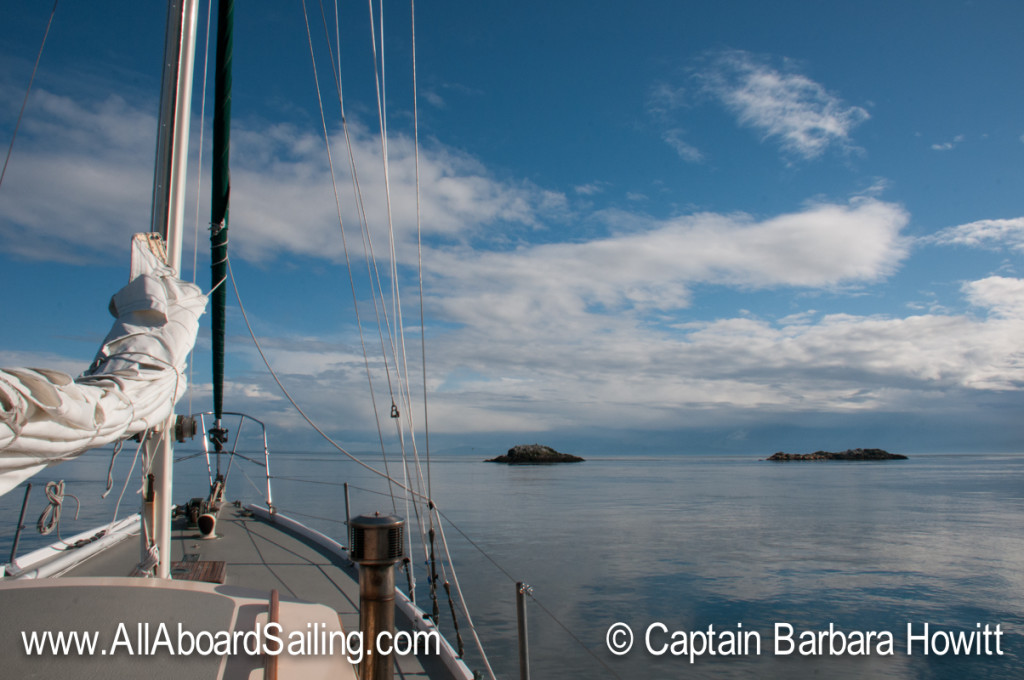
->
[0,85,567,262]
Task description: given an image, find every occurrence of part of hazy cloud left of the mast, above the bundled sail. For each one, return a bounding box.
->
[0,90,157,262]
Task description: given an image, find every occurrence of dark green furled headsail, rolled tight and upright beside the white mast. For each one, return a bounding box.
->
[210,0,234,456]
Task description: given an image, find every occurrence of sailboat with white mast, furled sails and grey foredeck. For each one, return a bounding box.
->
[0,0,493,680]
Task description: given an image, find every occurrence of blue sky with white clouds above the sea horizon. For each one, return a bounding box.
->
[0,1,1024,454]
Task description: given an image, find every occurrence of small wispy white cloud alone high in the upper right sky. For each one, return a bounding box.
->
[700,50,870,159]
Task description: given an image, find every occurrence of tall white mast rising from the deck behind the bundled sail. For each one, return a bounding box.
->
[148,0,199,579]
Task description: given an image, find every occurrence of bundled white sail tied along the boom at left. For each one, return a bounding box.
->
[0,233,206,495]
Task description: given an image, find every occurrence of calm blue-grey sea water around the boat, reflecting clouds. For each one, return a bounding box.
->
[0,448,1024,679]
